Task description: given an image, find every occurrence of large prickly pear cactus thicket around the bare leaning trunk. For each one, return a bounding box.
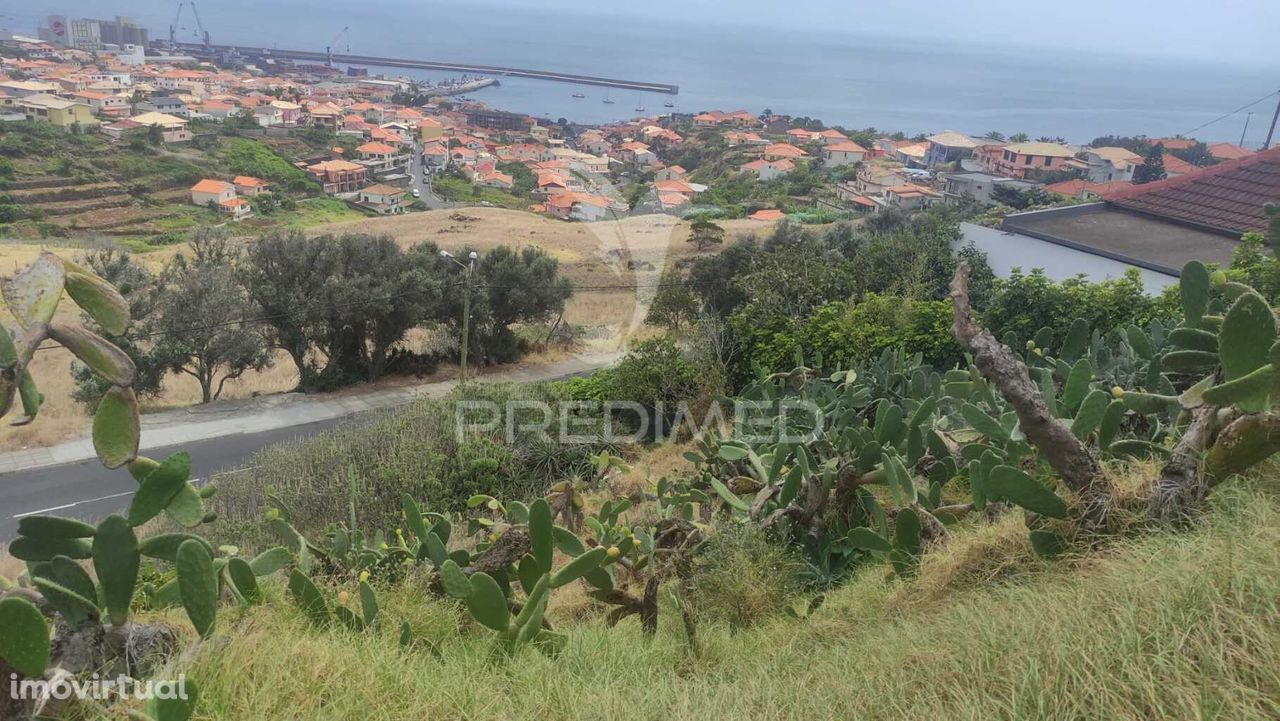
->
[691,261,1280,586]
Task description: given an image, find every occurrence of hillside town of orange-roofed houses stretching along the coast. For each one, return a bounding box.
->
[0,18,1275,284]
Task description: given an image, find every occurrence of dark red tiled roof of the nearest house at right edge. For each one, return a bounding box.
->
[1107,147,1280,234]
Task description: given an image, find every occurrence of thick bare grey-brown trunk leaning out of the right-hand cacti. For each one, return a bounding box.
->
[951,261,1111,526]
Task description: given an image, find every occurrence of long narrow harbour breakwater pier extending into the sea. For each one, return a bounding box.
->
[178,44,680,95]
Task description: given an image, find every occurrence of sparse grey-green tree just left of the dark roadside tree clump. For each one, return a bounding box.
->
[154,228,271,403]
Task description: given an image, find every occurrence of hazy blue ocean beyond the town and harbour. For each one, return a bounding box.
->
[12,0,1280,146]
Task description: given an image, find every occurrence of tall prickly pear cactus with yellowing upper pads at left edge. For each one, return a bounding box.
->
[0,252,278,720]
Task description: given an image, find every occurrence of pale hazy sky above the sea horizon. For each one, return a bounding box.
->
[0,0,1280,65]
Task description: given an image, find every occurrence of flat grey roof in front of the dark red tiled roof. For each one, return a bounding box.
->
[1002,202,1236,275]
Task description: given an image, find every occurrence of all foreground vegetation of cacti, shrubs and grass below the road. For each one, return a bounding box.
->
[0,209,1280,721]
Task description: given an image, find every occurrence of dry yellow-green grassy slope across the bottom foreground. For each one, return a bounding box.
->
[180,476,1280,721]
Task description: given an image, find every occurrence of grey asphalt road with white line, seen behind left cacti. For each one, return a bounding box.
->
[0,416,358,543]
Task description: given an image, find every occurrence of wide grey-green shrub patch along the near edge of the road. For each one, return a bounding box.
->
[210,383,614,546]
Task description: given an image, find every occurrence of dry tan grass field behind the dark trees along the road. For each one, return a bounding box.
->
[0,206,769,451]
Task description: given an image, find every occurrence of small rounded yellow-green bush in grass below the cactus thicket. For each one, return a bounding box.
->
[691,525,805,628]
